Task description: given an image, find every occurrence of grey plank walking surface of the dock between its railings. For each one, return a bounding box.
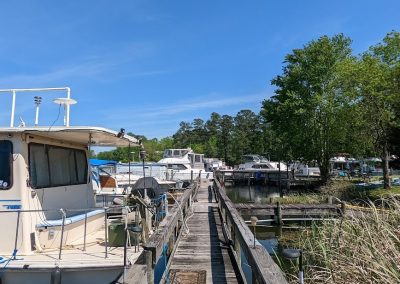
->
[170,185,243,283]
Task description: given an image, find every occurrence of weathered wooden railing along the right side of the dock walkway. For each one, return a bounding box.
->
[214,178,288,284]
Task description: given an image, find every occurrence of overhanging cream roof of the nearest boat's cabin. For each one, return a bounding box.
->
[0,126,139,147]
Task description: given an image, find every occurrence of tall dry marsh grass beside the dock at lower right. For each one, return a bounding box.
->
[286,198,400,283]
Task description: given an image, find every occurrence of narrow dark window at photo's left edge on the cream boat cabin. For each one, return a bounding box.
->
[0,140,13,190]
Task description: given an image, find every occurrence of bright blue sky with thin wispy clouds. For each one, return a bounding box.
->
[0,0,400,138]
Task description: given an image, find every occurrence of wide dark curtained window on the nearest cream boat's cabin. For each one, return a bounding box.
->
[29,143,87,188]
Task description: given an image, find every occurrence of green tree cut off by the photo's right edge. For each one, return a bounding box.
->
[357,32,400,188]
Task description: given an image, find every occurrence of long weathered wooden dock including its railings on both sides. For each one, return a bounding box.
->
[126,179,287,284]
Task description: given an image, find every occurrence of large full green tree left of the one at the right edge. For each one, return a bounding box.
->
[261,34,351,181]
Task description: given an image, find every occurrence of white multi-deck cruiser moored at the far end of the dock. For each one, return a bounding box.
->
[158,148,213,181]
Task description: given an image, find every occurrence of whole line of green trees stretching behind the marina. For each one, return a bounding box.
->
[98,31,400,187]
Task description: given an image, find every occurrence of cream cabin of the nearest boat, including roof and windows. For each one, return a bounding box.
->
[0,127,138,255]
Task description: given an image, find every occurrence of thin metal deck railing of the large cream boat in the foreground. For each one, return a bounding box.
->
[0,205,138,260]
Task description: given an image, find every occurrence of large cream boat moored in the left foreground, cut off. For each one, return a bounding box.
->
[0,87,147,284]
